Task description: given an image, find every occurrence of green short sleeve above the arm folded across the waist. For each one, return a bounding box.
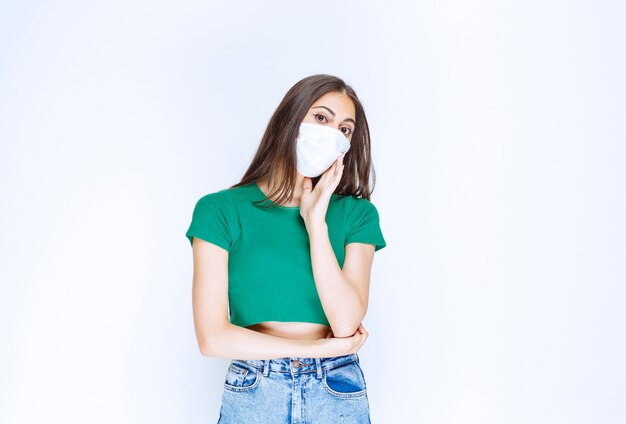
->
[185,190,233,252]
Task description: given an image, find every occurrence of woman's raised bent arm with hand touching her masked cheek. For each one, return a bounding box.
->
[300,155,375,337]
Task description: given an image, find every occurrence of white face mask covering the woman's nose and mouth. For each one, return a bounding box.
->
[296,122,350,178]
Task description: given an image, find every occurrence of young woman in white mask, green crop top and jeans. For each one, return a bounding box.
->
[186,74,386,424]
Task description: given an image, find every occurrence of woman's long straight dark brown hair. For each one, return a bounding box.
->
[230,74,376,208]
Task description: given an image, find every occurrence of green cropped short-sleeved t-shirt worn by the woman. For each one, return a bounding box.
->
[186,183,386,327]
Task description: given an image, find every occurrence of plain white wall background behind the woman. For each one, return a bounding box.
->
[0,0,626,424]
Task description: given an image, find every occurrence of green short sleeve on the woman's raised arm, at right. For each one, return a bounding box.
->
[345,198,387,251]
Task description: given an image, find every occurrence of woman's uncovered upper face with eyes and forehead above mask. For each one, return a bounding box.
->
[302,92,356,140]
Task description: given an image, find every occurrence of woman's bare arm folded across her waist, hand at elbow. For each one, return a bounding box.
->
[192,237,367,359]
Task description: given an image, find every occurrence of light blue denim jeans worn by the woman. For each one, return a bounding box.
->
[218,353,371,424]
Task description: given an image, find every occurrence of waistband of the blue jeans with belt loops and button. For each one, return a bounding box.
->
[232,353,359,378]
